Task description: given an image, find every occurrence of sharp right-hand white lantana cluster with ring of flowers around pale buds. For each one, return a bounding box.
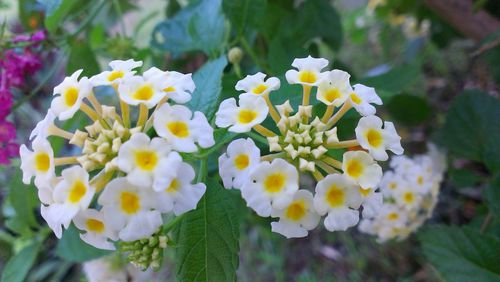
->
[215,56,403,238]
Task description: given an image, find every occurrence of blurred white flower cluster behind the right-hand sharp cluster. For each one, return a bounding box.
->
[359,145,446,242]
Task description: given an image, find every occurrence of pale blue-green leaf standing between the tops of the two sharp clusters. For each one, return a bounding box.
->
[188,56,227,120]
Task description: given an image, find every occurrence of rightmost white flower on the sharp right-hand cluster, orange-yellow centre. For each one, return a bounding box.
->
[355,116,404,161]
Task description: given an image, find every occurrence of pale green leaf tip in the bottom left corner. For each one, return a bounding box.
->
[2,241,41,282]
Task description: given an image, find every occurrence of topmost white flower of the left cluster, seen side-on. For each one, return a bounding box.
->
[90,59,142,86]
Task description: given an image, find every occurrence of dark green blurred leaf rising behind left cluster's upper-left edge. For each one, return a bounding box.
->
[66,39,100,76]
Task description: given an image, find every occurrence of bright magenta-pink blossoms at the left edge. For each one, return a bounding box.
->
[0,31,45,165]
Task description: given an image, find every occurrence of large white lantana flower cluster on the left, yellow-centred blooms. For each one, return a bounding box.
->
[20,60,214,249]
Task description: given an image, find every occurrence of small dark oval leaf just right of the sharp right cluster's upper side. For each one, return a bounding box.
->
[387,94,431,125]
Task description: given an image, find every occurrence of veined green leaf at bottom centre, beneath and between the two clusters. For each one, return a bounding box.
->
[176,179,242,282]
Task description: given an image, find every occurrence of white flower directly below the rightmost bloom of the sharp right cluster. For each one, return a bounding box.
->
[342,151,382,189]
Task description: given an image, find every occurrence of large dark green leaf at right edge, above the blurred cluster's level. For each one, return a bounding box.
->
[437,90,500,171]
